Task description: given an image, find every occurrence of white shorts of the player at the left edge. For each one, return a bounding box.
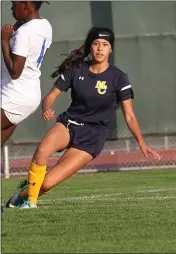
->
[1,102,39,125]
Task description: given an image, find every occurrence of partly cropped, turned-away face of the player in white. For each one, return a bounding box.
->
[11,1,27,21]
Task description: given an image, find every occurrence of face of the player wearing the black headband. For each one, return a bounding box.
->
[90,39,112,63]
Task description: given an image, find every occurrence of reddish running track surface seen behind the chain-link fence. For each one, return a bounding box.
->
[1,149,176,175]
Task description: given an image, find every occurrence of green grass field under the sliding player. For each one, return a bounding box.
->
[2,169,176,253]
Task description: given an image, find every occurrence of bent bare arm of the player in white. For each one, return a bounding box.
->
[1,25,26,79]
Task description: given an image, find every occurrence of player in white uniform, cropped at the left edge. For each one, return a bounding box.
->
[1,1,52,147]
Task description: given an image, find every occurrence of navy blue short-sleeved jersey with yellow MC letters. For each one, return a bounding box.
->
[54,62,134,126]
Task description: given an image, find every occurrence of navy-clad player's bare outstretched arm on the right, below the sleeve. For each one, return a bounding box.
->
[121,99,161,160]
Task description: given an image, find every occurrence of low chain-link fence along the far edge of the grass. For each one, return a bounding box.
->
[1,135,176,177]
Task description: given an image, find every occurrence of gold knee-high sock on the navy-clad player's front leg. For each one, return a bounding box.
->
[27,162,46,205]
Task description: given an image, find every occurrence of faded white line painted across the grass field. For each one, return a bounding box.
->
[38,188,176,204]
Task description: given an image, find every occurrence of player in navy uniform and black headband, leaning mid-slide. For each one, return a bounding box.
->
[5,28,160,208]
